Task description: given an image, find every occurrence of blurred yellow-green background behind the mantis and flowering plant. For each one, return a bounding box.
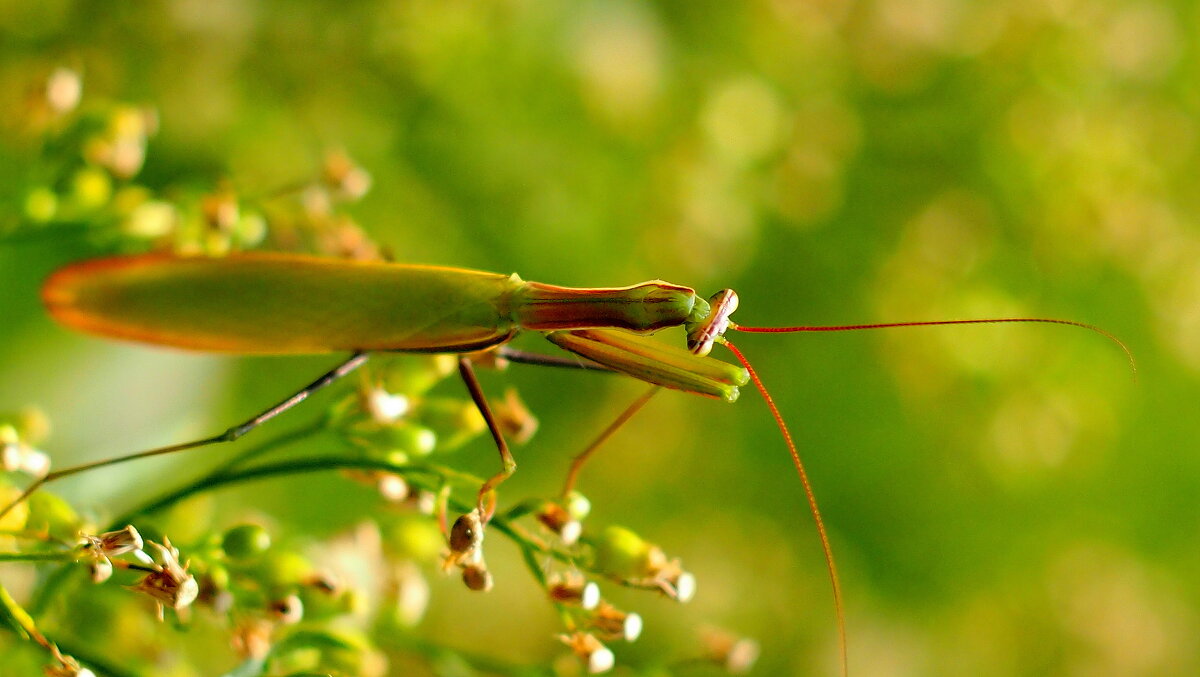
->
[0,0,1200,677]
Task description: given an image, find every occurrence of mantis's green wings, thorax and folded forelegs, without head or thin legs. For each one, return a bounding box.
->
[42,254,748,401]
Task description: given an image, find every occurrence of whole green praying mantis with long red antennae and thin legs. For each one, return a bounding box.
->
[0,253,1132,673]
